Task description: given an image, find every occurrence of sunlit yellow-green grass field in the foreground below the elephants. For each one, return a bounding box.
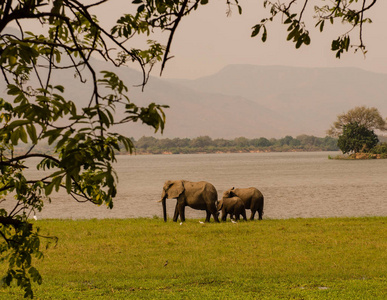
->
[0,217,387,299]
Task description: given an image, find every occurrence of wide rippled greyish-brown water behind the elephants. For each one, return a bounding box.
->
[1,152,387,219]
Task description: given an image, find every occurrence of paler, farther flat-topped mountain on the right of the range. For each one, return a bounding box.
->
[174,65,387,136]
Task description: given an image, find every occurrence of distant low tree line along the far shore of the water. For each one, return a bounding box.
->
[133,134,339,154]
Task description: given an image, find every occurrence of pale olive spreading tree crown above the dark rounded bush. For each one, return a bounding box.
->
[327,106,387,137]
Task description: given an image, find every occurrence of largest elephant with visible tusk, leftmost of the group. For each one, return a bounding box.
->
[159,180,219,222]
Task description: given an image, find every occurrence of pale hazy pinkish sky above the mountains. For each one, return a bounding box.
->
[93,0,387,79]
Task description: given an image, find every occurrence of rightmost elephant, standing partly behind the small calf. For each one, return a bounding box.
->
[223,187,264,220]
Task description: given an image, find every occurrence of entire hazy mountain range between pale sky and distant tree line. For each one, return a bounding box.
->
[0,61,387,139]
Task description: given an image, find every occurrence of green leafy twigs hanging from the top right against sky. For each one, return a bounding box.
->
[255,0,377,58]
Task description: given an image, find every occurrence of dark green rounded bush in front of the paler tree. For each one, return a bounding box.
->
[337,122,379,154]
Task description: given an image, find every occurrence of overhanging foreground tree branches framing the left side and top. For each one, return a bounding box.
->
[0,0,382,297]
